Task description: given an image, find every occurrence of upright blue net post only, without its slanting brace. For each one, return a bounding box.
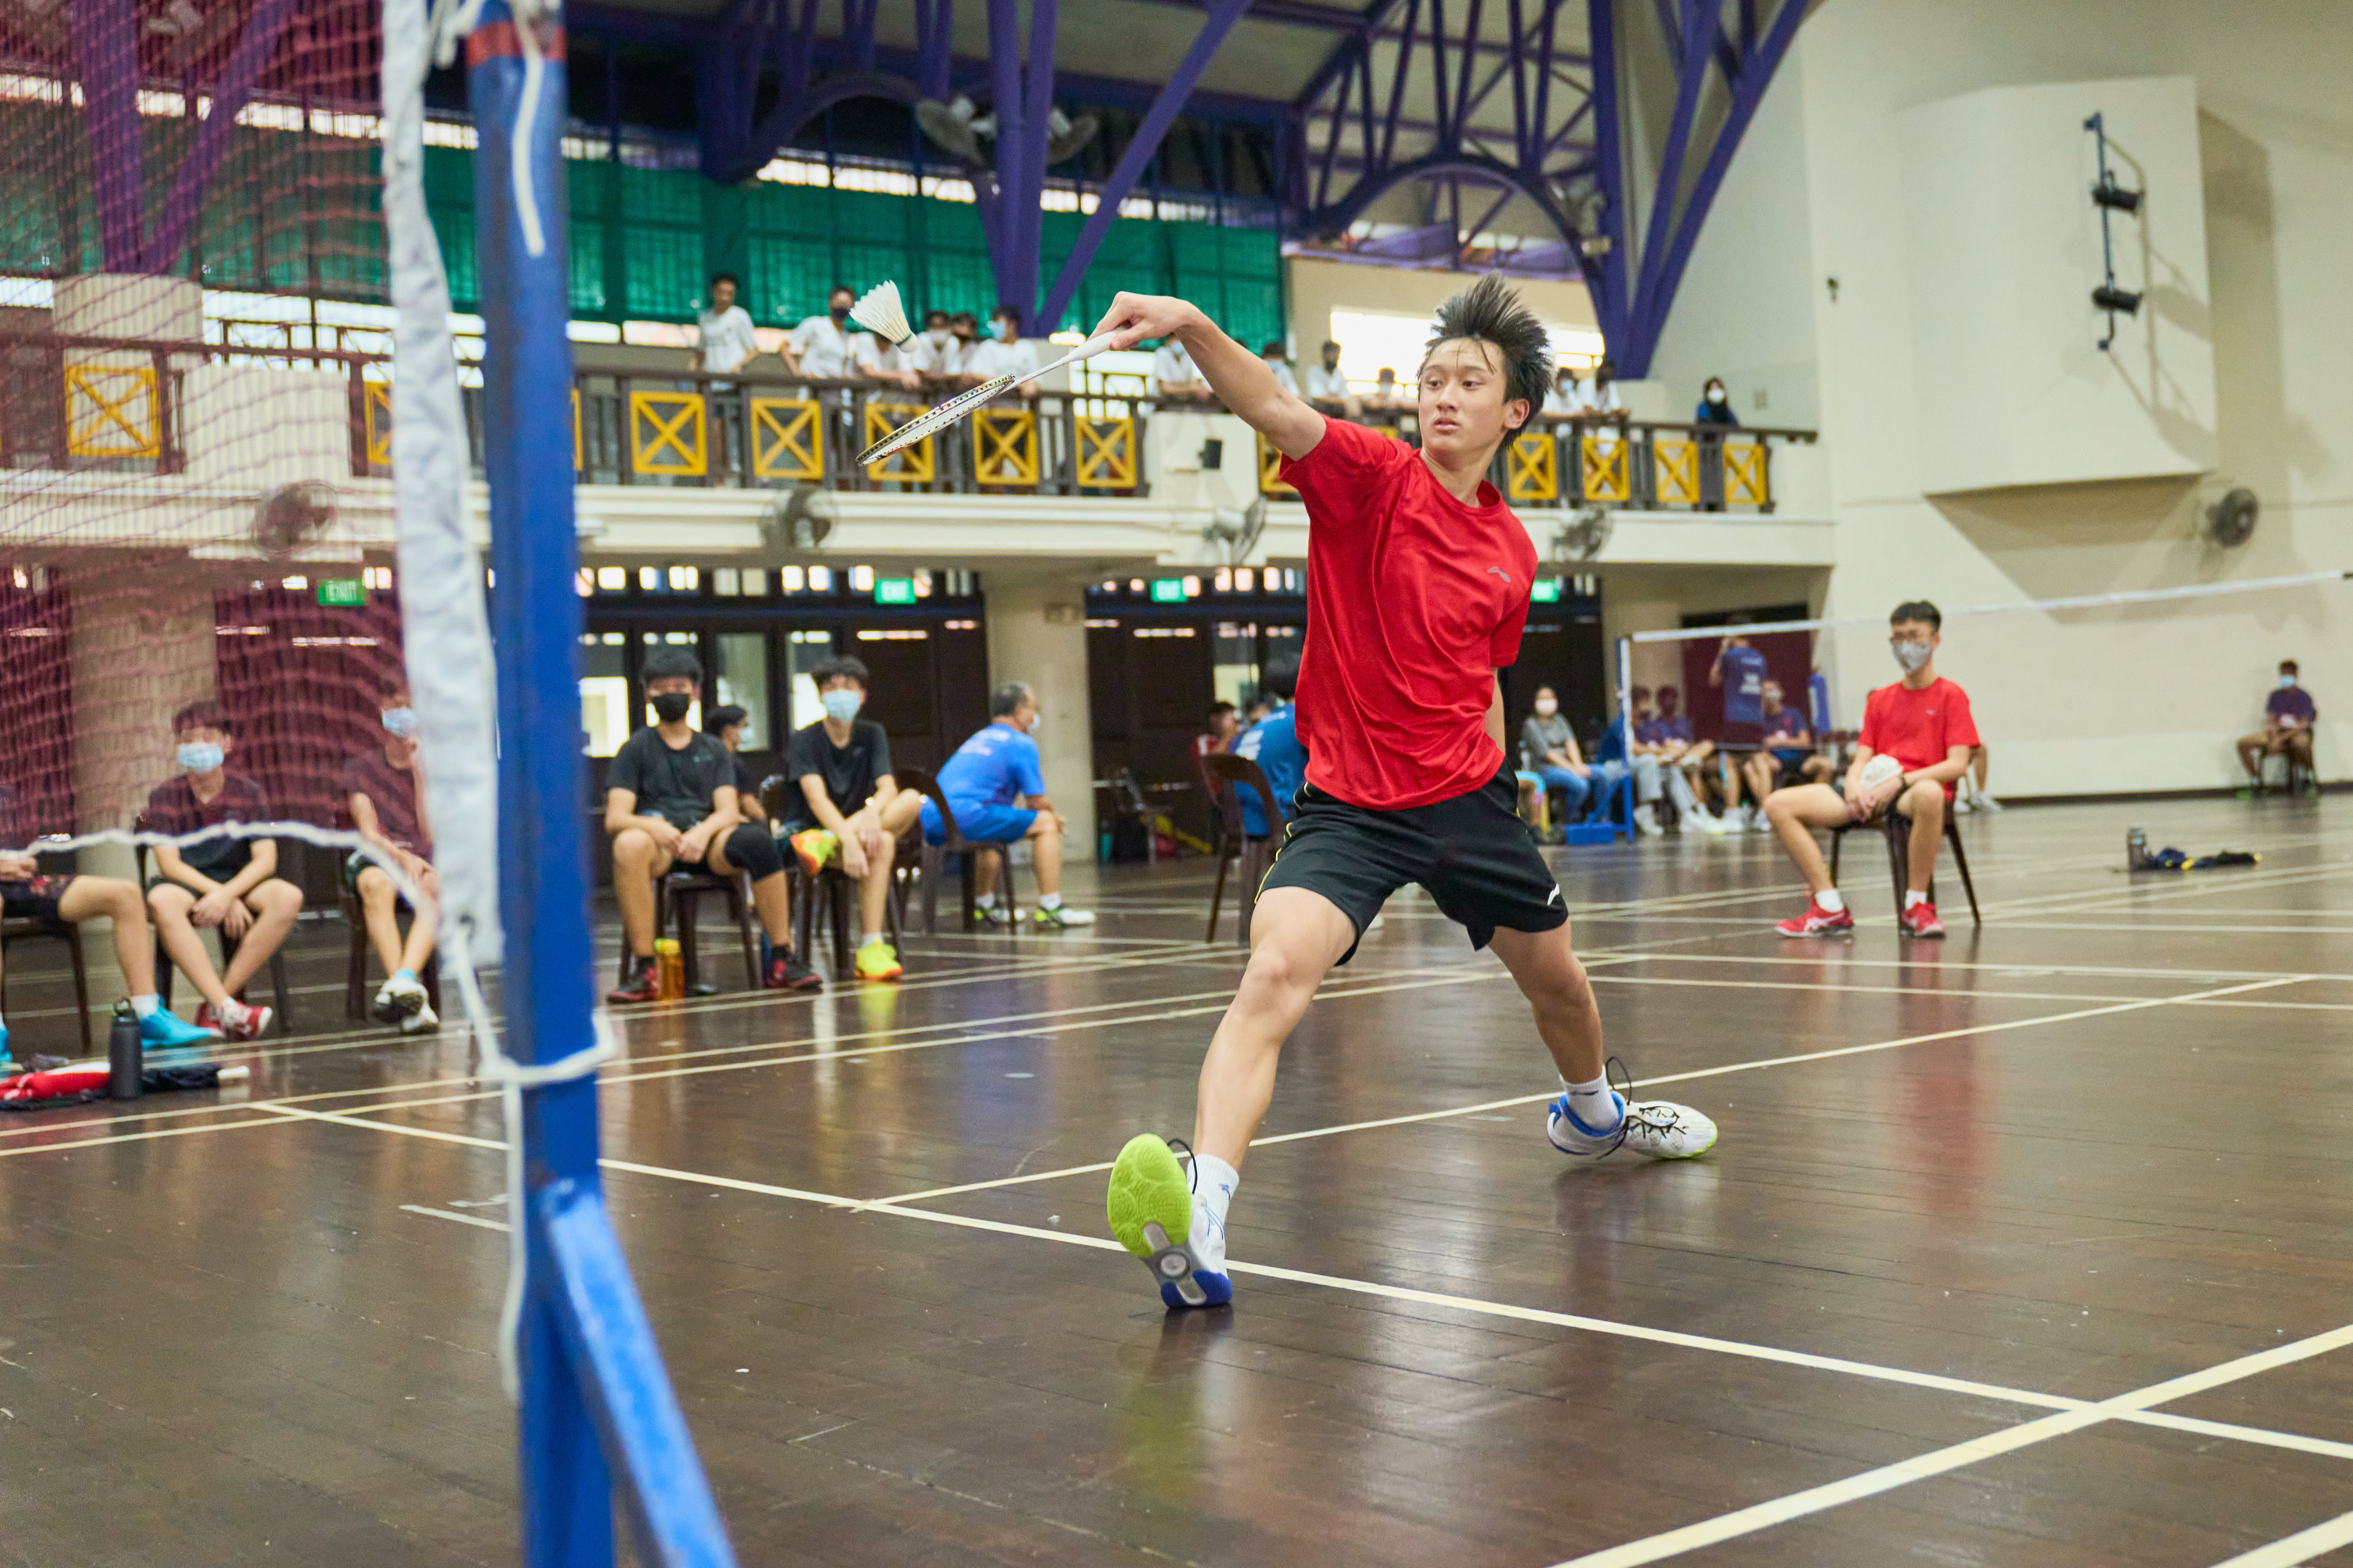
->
[466,15,614,1568]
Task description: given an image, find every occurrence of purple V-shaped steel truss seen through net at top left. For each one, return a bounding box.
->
[71,0,294,273]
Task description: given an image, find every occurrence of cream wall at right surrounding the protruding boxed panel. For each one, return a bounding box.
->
[1779,0,2353,795]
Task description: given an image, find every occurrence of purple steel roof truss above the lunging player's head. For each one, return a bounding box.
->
[1285,0,1807,376]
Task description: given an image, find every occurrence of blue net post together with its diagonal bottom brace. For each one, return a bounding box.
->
[466,0,734,1568]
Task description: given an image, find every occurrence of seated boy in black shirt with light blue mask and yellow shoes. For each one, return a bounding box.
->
[777,656,922,980]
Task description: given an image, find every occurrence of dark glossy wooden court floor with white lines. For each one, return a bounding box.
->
[0,799,2353,1568]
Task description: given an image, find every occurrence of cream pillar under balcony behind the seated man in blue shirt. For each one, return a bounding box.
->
[981,566,1094,860]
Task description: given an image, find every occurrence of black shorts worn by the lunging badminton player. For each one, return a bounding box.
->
[1259,762,1569,964]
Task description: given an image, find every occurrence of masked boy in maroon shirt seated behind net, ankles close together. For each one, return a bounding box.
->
[141,703,301,1039]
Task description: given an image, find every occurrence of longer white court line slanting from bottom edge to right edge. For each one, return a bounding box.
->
[1555,1326,2353,1568]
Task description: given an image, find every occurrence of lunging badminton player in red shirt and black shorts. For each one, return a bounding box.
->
[1097,277,1715,1307]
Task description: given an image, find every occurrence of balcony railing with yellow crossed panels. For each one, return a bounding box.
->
[0,332,1814,513]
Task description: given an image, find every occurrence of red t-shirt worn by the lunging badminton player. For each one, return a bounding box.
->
[1282,418,1536,811]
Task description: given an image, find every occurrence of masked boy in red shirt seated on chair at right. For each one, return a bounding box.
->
[1765,599,1976,935]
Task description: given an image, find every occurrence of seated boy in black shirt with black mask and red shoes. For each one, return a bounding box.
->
[605,644,821,1002]
